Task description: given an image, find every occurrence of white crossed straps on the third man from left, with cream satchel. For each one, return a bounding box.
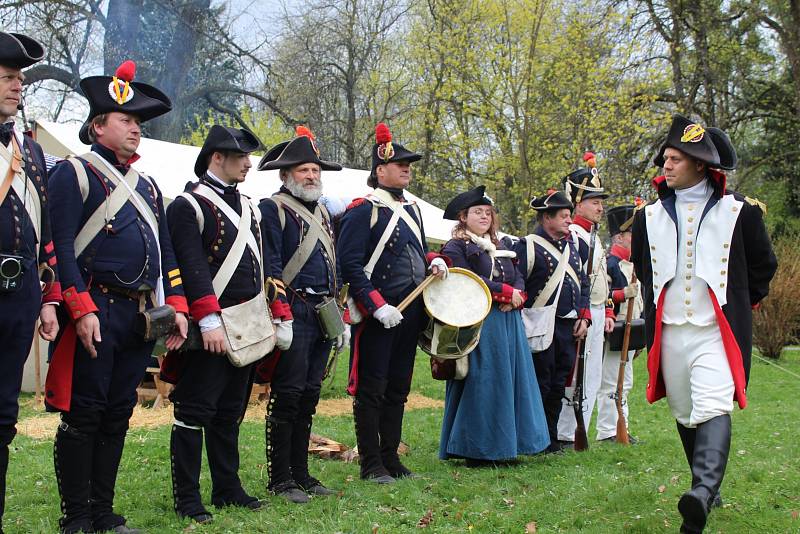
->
[180,184,264,298]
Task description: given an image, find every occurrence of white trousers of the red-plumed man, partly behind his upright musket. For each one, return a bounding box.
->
[558,307,606,441]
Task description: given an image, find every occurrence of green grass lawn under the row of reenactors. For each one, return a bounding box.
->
[4,351,800,534]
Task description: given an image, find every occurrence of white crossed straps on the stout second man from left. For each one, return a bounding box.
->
[67,152,164,306]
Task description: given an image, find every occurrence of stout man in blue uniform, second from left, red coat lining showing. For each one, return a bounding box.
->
[45,61,188,533]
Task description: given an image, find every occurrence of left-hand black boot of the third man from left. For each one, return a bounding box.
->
[169,425,211,523]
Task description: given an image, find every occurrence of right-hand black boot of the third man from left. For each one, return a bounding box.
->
[205,421,258,508]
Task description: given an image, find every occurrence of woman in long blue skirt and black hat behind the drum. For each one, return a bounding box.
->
[439,185,550,467]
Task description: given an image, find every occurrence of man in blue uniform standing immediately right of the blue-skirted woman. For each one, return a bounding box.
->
[514,190,591,452]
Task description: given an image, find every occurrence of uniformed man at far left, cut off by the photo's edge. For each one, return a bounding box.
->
[0,32,61,532]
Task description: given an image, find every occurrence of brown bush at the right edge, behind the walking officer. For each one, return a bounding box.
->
[753,234,800,360]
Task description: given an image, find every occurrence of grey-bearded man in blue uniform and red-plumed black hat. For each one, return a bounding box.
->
[258,126,344,503]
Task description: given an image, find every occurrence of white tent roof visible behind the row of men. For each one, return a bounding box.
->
[34,121,453,243]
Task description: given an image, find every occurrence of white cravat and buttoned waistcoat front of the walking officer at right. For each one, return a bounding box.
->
[663,180,716,326]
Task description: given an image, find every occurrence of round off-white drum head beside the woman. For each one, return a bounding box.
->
[422,267,492,327]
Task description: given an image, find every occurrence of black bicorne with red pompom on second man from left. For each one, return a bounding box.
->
[78,60,172,145]
